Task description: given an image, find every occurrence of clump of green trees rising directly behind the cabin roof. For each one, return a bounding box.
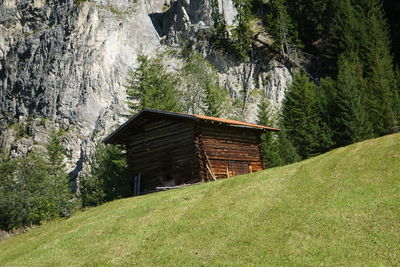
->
[126,50,227,116]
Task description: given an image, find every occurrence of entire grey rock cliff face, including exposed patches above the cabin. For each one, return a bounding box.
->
[0,0,291,180]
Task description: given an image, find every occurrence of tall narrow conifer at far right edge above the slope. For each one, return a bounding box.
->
[359,0,398,136]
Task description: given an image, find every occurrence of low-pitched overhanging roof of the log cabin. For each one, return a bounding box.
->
[103,108,280,144]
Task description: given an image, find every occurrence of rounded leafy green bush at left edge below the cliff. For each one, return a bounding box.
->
[0,153,73,230]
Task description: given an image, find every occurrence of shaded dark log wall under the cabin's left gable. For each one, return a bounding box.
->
[126,120,200,193]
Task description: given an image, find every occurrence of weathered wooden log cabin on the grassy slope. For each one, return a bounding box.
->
[103,109,279,195]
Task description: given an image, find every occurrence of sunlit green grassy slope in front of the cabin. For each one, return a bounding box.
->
[0,134,400,266]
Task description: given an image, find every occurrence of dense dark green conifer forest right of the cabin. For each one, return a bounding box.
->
[253,0,400,166]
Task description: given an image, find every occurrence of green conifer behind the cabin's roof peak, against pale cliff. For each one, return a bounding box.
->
[126,55,181,113]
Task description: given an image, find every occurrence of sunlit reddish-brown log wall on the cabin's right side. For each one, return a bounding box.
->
[197,126,264,180]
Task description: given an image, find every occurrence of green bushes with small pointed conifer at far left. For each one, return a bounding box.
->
[0,132,76,230]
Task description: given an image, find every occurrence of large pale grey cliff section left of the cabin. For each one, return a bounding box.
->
[0,0,164,177]
